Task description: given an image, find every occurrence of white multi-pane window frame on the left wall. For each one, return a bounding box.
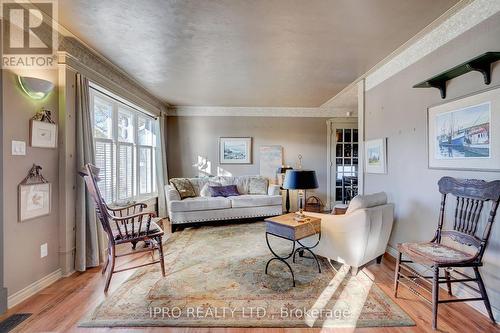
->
[89,85,158,204]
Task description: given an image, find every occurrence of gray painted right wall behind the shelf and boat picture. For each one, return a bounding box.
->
[365,14,500,320]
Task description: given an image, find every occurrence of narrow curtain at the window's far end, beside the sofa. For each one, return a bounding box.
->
[155,110,168,217]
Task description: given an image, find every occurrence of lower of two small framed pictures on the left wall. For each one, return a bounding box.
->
[19,183,51,221]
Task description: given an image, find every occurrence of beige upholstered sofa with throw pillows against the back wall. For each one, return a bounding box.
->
[165,176,283,231]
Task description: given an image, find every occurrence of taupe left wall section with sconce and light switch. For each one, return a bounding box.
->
[2,70,59,295]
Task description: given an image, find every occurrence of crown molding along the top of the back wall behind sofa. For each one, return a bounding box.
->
[167,106,356,118]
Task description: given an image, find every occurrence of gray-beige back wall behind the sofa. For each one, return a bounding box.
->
[167,117,327,203]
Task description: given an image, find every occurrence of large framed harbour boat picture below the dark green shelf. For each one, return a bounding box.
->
[427,87,500,171]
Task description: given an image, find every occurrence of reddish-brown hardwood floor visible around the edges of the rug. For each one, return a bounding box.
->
[0,224,500,333]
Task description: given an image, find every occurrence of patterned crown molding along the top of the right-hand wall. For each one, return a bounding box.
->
[365,0,500,90]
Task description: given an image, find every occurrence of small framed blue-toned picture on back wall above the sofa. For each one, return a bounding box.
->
[219,137,252,164]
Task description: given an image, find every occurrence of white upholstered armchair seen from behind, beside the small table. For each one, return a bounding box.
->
[304,192,394,275]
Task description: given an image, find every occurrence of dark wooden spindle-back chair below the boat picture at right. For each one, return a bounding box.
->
[394,177,500,329]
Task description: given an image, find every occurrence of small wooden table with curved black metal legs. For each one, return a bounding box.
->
[264,213,321,287]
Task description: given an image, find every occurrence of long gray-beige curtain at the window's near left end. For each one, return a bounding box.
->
[75,74,105,272]
